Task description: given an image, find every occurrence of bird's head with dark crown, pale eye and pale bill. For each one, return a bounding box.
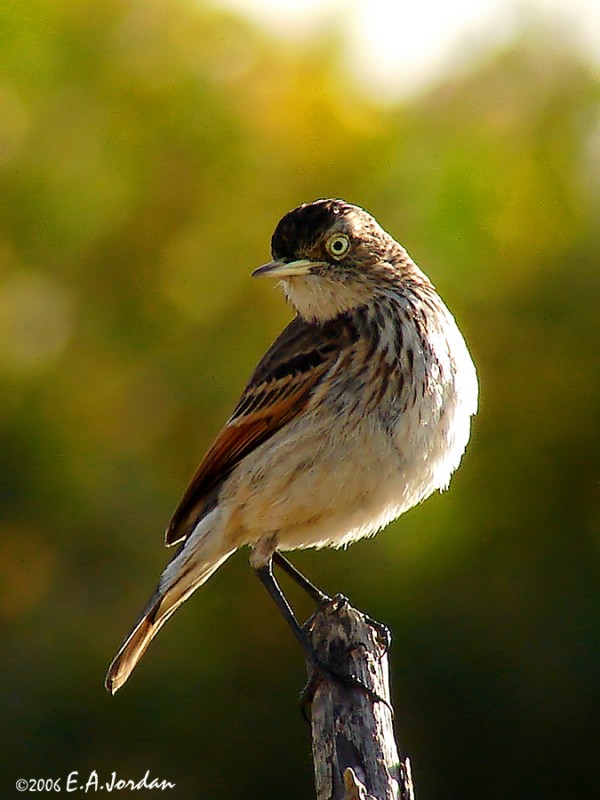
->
[253,200,411,322]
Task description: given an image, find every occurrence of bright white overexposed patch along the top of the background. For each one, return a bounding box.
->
[213,0,600,100]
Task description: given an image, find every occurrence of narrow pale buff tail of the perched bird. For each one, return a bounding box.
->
[105,510,235,694]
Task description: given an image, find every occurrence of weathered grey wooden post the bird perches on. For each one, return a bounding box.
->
[304,595,414,800]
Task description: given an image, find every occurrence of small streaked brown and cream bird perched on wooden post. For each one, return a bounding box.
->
[105,199,478,694]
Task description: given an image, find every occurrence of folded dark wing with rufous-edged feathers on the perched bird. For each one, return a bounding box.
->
[165,315,358,545]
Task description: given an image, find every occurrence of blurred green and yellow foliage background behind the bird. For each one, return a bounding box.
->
[0,0,600,800]
